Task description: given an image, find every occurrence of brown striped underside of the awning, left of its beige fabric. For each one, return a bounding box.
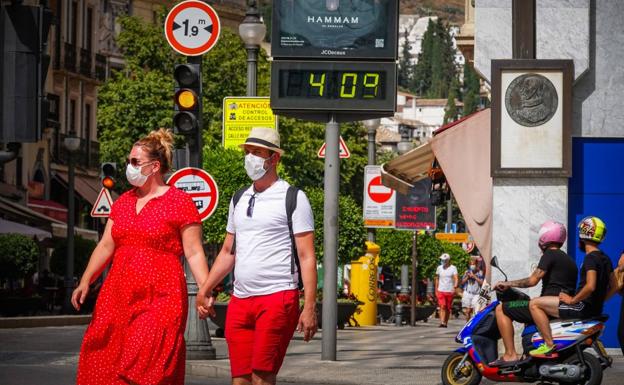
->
[381,142,435,194]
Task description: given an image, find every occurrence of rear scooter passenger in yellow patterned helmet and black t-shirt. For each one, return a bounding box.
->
[529,216,617,357]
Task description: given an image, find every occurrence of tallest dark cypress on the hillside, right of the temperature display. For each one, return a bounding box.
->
[412,19,457,99]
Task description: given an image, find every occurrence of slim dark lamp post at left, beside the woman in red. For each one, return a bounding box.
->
[63,130,80,314]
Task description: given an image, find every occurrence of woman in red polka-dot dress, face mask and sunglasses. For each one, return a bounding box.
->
[72,129,208,385]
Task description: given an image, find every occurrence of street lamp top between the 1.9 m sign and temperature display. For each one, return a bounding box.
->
[238,0,266,96]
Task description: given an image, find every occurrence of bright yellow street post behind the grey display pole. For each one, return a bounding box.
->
[351,241,380,326]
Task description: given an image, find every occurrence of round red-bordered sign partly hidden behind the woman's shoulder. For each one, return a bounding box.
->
[167,167,219,221]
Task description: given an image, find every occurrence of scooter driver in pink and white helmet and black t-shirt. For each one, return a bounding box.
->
[492,221,578,366]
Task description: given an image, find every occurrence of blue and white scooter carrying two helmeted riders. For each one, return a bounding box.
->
[441,256,613,385]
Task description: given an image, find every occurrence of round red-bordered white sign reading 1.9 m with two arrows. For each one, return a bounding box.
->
[165,0,221,56]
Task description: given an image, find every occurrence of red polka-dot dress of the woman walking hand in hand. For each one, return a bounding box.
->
[77,187,201,385]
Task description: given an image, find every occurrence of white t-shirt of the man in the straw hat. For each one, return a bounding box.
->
[227,179,314,298]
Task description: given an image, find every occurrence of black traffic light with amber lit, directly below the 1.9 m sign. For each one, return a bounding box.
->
[173,63,201,136]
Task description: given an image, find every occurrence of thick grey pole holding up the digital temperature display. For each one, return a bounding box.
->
[321,114,340,361]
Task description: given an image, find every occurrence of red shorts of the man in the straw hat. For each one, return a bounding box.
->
[225,290,299,378]
